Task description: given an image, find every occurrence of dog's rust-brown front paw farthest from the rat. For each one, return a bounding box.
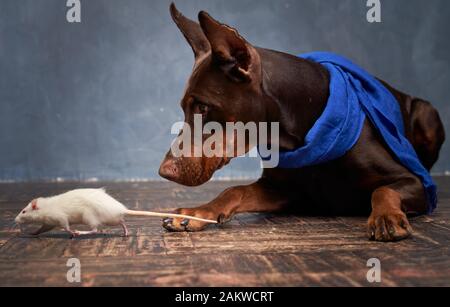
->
[368,211,412,242]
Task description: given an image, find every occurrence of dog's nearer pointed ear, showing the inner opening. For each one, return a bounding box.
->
[198,11,253,82]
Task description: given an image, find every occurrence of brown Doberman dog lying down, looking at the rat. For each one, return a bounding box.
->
[160,5,445,241]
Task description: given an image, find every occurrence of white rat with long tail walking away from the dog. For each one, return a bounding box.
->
[15,189,217,237]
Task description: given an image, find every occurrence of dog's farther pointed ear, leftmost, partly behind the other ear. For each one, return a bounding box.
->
[170,2,211,58]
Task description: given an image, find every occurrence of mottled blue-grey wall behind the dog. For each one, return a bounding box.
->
[0,0,450,181]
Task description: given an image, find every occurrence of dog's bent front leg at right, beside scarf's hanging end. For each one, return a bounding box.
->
[368,180,426,242]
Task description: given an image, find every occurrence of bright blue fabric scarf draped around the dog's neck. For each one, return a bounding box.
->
[270,52,437,213]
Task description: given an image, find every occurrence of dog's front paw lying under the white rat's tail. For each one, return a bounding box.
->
[163,208,217,232]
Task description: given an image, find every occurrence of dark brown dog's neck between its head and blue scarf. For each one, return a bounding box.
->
[257,48,329,150]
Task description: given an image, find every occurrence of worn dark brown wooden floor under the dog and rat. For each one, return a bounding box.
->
[0,177,450,286]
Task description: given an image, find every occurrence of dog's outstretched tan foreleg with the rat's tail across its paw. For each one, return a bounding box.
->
[163,181,287,231]
